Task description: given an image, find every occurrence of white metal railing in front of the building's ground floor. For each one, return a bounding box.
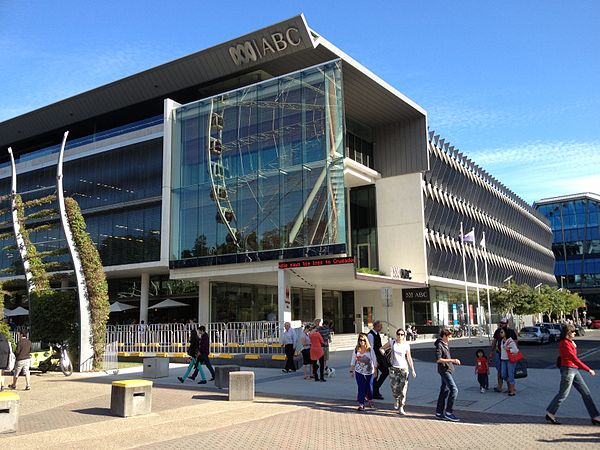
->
[106,321,290,356]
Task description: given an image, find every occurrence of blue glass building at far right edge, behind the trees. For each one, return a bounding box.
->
[534,192,600,318]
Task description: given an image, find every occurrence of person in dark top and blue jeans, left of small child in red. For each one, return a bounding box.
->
[435,328,460,422]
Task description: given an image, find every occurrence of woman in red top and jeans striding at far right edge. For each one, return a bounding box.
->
[546,325,600,425]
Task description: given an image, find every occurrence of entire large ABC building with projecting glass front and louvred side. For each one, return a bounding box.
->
[0,15,554,332]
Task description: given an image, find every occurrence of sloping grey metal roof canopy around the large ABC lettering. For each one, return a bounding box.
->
[0,14,426,151]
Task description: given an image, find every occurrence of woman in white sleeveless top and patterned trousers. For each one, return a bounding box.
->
[379,328,417,415]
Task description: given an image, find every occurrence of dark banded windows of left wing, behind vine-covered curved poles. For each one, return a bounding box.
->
[0,140,162,276]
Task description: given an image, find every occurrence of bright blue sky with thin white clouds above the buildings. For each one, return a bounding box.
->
[0,0,600,203]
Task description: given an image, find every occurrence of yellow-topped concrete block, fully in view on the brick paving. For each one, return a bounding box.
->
[110,380,152,417]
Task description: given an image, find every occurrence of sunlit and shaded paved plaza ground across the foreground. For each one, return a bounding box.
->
[0,330,600,449]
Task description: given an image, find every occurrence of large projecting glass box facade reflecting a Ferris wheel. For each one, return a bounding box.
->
[170,61,346,268]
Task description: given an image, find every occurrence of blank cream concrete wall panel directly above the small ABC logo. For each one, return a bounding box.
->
[375,173,428,283]
